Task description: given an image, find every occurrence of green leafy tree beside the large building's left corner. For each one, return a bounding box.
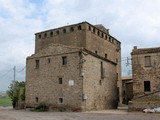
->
[7,81,25,108]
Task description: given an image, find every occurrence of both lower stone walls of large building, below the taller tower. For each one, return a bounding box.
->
[26,44,118,111]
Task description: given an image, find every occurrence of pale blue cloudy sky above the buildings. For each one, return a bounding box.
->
[0,0,160,91]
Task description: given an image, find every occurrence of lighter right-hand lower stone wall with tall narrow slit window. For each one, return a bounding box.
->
[82,51,118,110]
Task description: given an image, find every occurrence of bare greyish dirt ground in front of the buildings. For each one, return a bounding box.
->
[0,107,160,120]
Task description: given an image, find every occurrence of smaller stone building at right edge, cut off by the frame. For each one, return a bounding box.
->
[131,46,160,109]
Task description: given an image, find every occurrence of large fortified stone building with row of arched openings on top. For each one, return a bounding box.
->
[26,22,121,111]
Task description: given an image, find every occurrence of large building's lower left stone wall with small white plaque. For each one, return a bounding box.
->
[26,47,82,109]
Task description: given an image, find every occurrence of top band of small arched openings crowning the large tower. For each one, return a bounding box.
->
[35,22,121,48]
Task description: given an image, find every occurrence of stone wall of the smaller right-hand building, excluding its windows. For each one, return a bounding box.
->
[132,46,160,97]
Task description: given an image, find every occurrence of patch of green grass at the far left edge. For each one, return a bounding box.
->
[0,96,12,107]
